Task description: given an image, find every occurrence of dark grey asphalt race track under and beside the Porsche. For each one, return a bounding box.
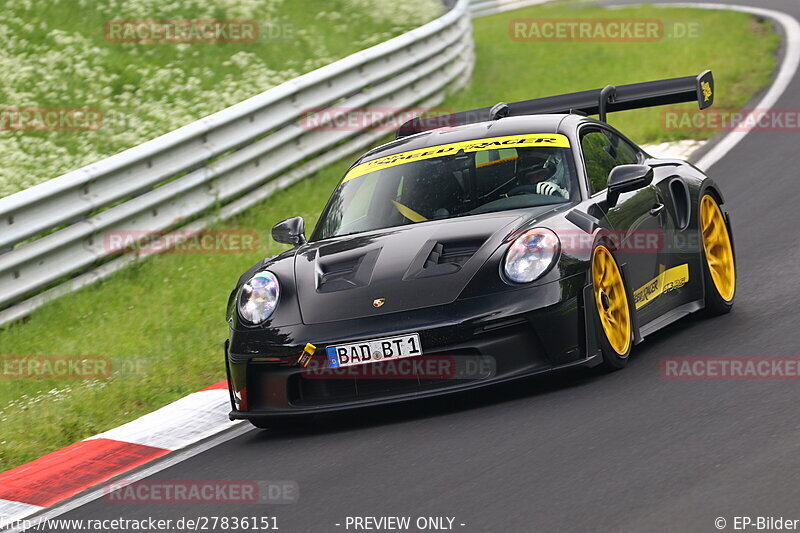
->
[42,0,800,533]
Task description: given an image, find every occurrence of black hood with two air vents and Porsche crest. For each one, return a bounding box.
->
[295,212,532,324]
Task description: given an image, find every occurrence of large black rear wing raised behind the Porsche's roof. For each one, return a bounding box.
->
[397,70,714,138]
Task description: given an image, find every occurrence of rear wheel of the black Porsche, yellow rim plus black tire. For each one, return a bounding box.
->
[698,193,736,316]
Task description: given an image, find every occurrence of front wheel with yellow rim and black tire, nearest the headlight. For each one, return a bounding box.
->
[591,245,633,371]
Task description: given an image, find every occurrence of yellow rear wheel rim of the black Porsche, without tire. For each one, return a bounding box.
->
[700,194,736,302]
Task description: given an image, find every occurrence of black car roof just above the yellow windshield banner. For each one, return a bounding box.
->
[358,114,585,163]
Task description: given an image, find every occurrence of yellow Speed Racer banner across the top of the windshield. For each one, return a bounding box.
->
[342,133,569,183]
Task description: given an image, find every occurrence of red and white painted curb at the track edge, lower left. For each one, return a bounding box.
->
[0,381,241,528]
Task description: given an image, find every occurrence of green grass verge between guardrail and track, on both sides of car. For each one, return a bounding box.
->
[0,6,778,470]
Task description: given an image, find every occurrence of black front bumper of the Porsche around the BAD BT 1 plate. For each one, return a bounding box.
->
[226,275,587,420]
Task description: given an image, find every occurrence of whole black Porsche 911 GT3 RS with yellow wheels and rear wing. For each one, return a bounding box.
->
[225,72,736,427]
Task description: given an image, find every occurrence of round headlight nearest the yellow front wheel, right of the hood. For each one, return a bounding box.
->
[503,228,560,283]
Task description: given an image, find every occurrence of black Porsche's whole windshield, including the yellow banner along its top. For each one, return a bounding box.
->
[313,134,580,240]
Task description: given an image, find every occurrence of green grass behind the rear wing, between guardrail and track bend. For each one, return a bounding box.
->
[445,4,779,144]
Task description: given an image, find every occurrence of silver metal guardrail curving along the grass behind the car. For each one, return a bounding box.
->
[0,0,474,325]
